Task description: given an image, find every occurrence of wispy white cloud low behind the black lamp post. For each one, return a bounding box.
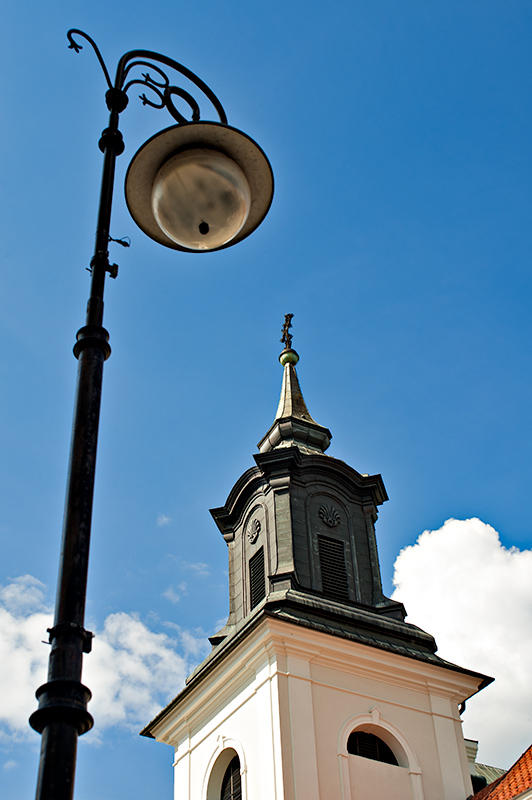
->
[0,575,204,741]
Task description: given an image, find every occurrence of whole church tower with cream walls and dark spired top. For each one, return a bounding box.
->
[142,315,491,800]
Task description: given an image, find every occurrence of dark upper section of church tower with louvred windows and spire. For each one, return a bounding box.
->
[211,324,424,656]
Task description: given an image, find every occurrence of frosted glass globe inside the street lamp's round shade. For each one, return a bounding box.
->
[152,148,251,250]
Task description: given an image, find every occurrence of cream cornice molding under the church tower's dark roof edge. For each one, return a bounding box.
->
[141,616,491,746]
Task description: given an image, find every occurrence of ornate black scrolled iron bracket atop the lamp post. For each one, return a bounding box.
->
[67,28,227,124]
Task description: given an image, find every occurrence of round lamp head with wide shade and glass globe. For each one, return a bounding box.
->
[125,122,273,253]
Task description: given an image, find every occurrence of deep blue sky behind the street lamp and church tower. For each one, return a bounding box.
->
[0,0,532,800]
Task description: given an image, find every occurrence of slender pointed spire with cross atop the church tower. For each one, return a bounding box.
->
[258,314,332,453]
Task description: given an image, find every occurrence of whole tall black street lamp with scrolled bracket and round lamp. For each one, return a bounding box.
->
[30,29,273,800]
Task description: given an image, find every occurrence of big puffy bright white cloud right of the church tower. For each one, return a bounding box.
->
[393,518,532,766]
